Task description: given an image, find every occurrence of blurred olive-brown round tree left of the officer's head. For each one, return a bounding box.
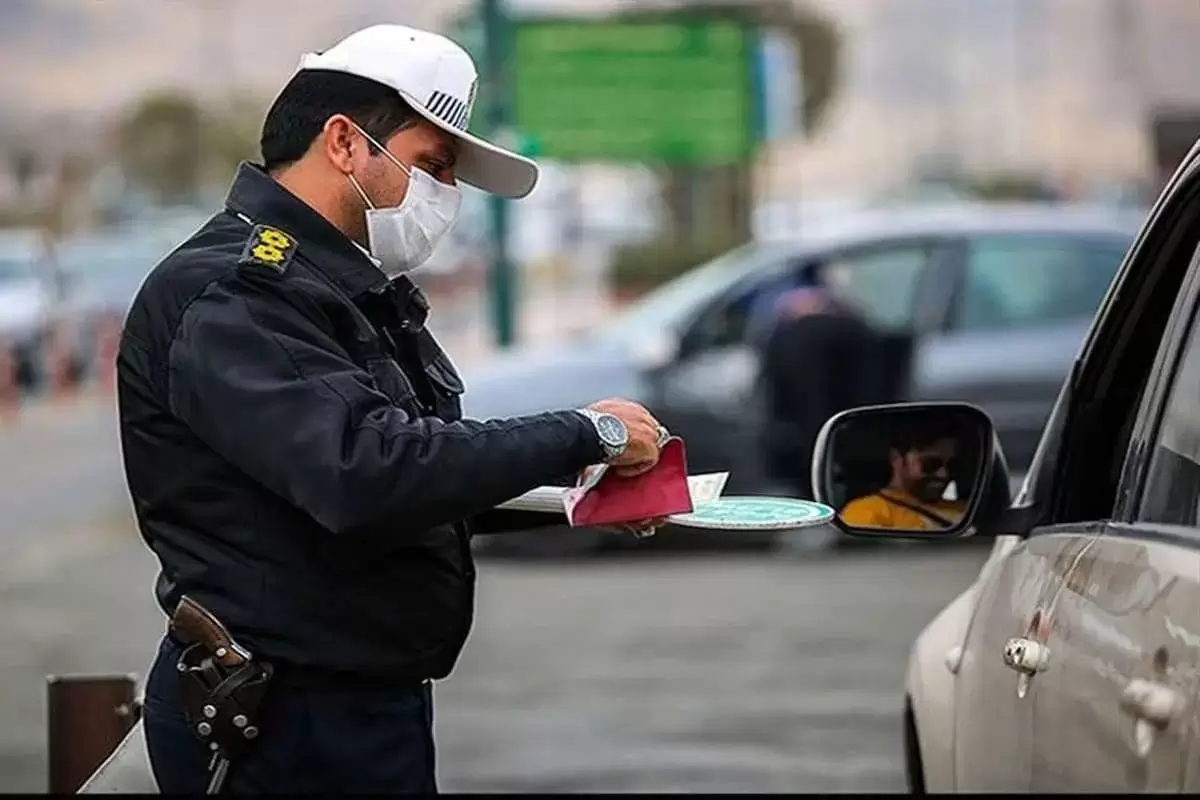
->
[116,90,205,204]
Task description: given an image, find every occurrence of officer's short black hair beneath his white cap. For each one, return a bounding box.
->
[259,70,421,172]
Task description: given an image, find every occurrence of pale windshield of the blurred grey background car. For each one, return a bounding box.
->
[599,242,796,341]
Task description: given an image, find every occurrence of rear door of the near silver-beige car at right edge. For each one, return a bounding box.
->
[1033,253,1200,793]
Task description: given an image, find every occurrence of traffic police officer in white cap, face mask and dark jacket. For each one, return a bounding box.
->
[118,25,664,793]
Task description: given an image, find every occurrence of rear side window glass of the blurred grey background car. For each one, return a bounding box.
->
[953,236,1124,331]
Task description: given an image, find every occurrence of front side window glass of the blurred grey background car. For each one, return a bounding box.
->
[824,245,929,330]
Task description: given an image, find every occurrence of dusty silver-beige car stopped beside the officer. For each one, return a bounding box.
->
[812,146,1200,794]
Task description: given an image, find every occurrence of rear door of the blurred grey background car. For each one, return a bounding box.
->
[913,233,1129,471]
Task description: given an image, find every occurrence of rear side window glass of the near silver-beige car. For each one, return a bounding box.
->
[1136,281,1200,527]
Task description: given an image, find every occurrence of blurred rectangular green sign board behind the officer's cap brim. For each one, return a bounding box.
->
[510,19,757,166]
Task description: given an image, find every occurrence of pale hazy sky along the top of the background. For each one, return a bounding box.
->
[7,0,1200,199]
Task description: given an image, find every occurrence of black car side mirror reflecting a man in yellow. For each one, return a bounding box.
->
[812,403,1012,539]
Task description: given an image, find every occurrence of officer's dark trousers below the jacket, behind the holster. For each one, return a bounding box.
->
[143,638,438,794]
